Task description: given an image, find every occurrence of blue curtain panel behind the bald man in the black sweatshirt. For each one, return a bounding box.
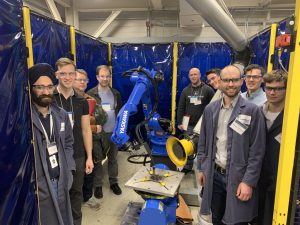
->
[177,43,231,100]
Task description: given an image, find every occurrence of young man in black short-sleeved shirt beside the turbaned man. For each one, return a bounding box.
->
[54,58,94,225]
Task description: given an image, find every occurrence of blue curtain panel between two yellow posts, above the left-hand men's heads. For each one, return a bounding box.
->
[75,32,108,89]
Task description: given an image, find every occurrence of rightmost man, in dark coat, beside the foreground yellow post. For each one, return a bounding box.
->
[258,70,287,225]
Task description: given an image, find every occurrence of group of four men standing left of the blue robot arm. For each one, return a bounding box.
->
[28,58,122,225]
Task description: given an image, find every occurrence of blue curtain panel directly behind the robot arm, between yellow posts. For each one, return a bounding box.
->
[112,44,173,121]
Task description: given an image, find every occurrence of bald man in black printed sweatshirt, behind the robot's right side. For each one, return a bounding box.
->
[177,68,214,173]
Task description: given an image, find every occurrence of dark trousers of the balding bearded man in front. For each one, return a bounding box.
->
[211,171,248,225]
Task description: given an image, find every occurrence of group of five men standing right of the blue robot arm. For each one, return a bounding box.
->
[177,64,287,225]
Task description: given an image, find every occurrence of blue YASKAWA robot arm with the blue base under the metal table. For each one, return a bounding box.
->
[111,68,178,225]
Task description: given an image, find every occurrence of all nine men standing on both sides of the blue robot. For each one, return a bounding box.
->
[29,58,287,225]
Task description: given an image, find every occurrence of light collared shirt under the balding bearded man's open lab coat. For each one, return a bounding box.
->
[216,95,239,169]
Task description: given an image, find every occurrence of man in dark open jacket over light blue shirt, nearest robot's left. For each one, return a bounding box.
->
[87,65,122,199]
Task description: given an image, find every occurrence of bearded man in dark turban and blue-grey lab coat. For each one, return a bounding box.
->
[29,63,75,225]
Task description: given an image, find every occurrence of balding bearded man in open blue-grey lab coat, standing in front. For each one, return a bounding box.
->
[197,65,265,225]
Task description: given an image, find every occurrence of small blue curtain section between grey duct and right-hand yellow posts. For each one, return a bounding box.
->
[250,29,271,68]
